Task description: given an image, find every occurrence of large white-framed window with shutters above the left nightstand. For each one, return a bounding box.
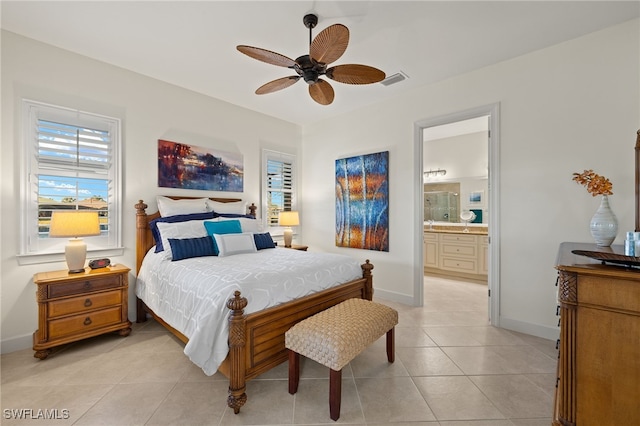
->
[19,100,122,263]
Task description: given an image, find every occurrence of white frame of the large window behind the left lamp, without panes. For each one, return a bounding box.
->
[17,99,124,265]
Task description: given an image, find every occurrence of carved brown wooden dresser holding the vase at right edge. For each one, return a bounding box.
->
[553,243,640,426]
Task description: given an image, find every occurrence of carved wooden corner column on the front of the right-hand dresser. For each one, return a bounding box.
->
[554,271,578,425]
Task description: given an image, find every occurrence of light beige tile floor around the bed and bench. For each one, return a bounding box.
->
[0,277,557,426]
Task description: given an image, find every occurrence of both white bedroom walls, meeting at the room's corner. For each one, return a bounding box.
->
[0,20,640,352]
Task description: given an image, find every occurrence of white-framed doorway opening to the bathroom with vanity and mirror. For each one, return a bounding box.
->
[414,104,499,326]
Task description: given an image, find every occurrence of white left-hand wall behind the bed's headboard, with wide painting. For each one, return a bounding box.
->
[0,31,300,352]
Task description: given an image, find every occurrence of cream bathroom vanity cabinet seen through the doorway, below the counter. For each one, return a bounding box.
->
[423,232,489,281]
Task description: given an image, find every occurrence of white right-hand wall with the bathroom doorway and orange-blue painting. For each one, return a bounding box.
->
[301,19,640,338]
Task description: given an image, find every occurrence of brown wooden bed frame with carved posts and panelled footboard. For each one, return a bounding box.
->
[135,196,373,414]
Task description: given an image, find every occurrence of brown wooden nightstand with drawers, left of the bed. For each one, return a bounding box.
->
[33,265,131,359]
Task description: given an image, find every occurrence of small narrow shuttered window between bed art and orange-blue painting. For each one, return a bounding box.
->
[262,150,296,234]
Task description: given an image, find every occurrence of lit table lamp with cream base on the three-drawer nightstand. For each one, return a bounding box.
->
[49,210,100,274]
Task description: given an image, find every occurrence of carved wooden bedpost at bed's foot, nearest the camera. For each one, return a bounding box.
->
[227,290,248,414]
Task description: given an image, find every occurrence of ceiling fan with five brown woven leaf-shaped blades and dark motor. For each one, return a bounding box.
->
[237,14,385,105]
